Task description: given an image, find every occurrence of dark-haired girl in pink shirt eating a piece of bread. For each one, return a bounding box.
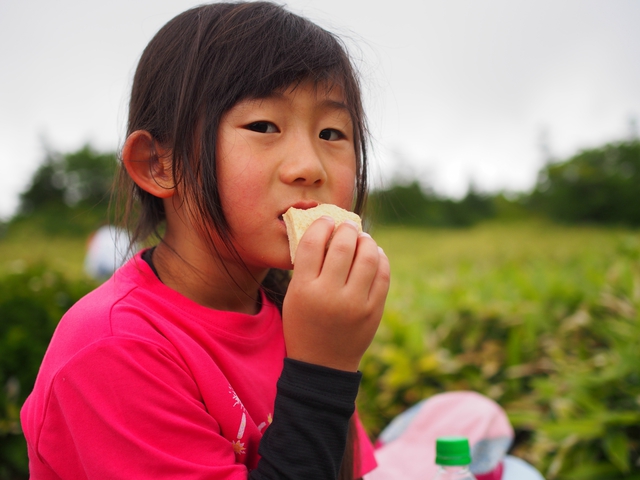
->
[21,2,389,480]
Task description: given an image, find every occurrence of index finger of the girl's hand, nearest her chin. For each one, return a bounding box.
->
[294,216,335,279]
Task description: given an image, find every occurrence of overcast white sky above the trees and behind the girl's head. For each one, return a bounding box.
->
[0,0,640,218]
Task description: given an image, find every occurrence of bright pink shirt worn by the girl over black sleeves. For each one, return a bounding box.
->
[21,255,375,479]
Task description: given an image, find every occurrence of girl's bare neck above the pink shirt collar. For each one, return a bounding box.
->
[153,237,267,315]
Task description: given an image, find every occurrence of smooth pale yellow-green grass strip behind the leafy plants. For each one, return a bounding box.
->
[0,218,624,284]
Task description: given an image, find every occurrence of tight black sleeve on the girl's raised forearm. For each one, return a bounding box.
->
[249,358,362,480]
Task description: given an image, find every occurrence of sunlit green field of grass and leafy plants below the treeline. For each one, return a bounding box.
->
[0,222,640,480]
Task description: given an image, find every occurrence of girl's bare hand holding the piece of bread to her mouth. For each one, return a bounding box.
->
[282,217,390,372]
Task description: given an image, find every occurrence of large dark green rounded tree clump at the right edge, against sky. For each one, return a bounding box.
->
[529,140,640,226]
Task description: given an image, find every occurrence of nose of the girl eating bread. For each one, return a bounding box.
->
[280,142,327,186]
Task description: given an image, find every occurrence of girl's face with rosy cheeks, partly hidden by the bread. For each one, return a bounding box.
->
[216,82,356,270]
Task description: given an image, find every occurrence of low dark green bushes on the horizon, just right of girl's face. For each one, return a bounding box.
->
[370,181,495,227]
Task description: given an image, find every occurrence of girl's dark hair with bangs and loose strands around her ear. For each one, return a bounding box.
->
[119,2,367,478]
